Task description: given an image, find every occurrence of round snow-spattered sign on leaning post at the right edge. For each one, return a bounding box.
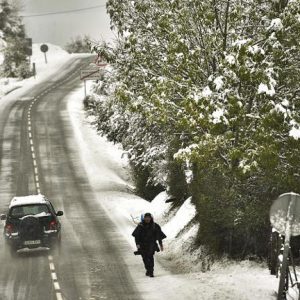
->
[270,193,300,300]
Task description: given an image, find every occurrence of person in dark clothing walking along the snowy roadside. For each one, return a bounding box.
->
[132,213,167,277]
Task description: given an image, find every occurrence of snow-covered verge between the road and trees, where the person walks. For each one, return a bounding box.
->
[68,85,288,300]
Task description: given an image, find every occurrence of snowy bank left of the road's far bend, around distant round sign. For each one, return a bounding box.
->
[0,43,83,99]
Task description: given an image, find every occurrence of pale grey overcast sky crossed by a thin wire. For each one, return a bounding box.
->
[19,0,113,46]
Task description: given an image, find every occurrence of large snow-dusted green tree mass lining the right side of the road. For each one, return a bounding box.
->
[90,0,300,255]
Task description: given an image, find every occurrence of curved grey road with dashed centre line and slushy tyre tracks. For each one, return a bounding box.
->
[0,58,141,300]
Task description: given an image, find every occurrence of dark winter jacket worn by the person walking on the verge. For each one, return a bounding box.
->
[132,220,166,255]
